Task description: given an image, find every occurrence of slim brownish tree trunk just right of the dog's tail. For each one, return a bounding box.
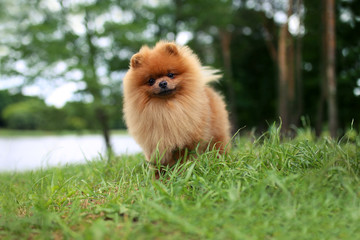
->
[220,30,239,133]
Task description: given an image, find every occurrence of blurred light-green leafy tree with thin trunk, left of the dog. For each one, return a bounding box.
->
[2,0,146,151]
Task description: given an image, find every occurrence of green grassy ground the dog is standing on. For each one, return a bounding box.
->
[0,128,360,239]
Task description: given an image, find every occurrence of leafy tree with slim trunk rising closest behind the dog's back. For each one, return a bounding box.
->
[175,0,240,132]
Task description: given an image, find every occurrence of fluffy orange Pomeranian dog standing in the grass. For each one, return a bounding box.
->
[123,41,230,169]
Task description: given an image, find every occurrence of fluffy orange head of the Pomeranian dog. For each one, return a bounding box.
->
[124,42,201,99]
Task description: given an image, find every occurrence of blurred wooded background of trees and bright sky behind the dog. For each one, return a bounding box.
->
[0,0,360,150]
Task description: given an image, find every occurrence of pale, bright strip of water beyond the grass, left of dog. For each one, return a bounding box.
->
[0,135,141,171]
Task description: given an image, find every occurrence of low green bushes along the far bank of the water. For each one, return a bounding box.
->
[0,91,125,131]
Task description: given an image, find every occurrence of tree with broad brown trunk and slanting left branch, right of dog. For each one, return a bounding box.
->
[264,0,304,133]
